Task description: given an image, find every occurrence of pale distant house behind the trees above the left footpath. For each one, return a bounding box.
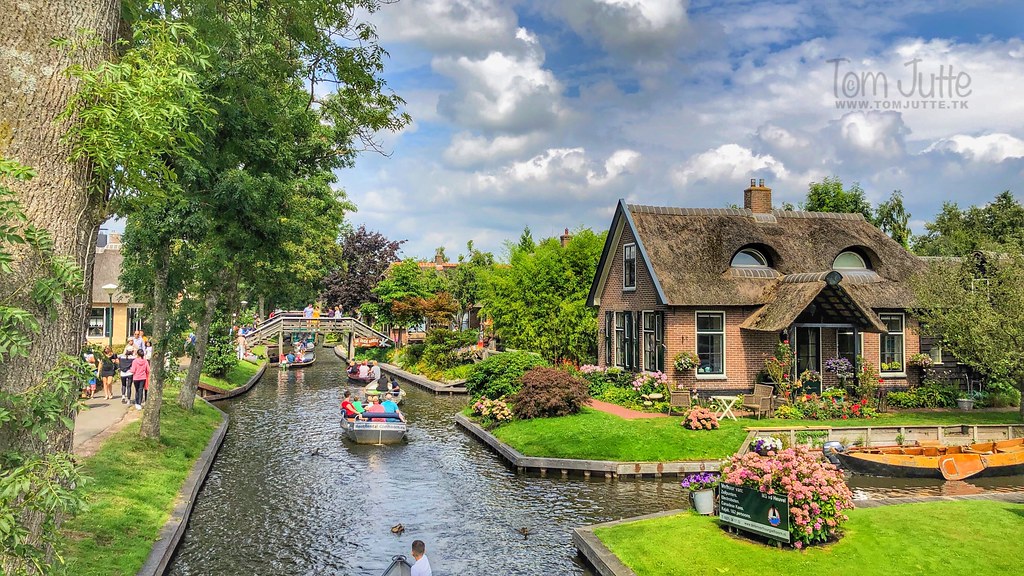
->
[86,232,142,344]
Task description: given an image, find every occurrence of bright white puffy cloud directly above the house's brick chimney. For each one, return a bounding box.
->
[672,143,787,187]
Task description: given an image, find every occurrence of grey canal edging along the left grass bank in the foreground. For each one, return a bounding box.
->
[136,398,229,576]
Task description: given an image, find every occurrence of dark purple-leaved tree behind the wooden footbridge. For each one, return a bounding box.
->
[322,225,406,311]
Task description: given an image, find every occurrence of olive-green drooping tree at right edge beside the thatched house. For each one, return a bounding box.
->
[913,251,1024,418]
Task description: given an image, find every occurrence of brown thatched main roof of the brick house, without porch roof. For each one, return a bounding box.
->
[618,202,925,308]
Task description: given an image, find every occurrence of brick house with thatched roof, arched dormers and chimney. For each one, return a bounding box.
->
[588,180,942,392]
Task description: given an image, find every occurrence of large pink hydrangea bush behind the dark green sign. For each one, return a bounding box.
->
[722,446,853,548]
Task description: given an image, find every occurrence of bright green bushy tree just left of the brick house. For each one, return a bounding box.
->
[482,229,604,364]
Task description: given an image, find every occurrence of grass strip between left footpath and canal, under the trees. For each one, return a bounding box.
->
[65,397,221,576]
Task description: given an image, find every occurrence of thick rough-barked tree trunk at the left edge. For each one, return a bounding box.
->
[0,0,121,574]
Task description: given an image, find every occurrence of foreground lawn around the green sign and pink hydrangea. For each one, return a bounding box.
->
[594,500,1024,576]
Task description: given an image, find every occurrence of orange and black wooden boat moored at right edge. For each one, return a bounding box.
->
[836,438,1024,480]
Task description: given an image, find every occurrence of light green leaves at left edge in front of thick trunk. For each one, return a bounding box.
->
[0,158,89,574]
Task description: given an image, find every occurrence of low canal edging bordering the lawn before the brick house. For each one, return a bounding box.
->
[455,414,724,479]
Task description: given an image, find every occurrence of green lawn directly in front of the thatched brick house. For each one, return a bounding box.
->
[489,408,1021,462]
